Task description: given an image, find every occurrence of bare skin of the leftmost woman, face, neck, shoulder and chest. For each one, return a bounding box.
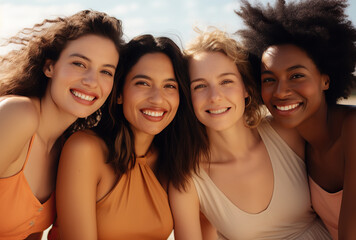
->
[0,35,119,239]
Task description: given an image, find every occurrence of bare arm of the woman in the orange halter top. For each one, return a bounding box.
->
[56,132,104,240]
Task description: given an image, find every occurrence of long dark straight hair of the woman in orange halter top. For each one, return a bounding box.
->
[94,34,206,188]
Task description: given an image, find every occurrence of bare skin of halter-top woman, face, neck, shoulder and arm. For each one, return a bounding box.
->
[56,53,179,240]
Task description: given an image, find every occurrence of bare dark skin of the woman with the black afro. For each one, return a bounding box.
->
[261,44,356,239]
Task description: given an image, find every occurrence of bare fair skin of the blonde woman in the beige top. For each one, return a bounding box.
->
[169,52,303,240]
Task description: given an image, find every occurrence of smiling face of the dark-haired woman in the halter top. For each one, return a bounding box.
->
[118,53,179,139]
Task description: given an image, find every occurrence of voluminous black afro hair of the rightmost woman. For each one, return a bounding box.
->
[235,0,356,105]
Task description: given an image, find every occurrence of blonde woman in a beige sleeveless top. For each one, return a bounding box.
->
[170,30,330,240]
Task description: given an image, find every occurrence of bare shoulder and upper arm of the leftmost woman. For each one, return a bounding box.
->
[0,96,39,177]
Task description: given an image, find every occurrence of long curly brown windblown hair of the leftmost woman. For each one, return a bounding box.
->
[0,10,124,129]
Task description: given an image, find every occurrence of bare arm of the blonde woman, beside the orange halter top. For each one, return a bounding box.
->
[168,179,202,240]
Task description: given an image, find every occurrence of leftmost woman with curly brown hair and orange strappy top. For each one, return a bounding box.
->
[0,10,123,240]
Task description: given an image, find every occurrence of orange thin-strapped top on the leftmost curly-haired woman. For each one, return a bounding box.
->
[0,136,55,240]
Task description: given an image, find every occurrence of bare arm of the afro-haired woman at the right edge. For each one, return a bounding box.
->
[339,112,356,240]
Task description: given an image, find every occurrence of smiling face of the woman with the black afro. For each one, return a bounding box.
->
[261,44,329,128]
